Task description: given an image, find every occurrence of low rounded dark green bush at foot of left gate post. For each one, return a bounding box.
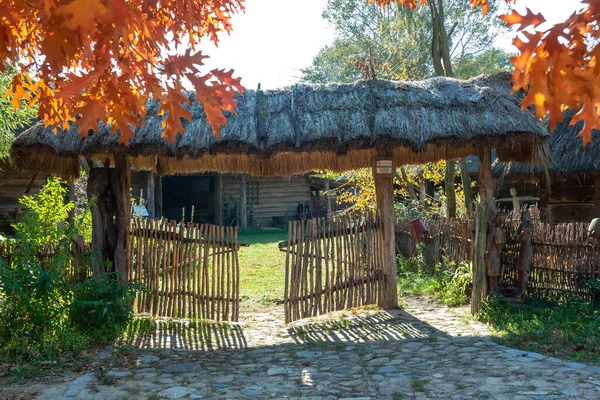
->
[69,273,135,334]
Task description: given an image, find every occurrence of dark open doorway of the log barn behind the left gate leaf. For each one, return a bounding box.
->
[162,175,216,224]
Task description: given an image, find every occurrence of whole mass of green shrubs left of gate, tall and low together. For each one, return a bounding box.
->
[0,178,133,377]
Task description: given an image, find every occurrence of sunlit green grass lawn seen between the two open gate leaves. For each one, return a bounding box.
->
[238,230,287,310]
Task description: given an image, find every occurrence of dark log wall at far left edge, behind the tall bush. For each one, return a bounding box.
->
[0,162,48,235]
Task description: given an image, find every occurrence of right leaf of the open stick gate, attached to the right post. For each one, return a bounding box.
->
[280,213,384,323]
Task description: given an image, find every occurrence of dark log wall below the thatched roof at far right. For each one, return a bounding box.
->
[547,174,600,223]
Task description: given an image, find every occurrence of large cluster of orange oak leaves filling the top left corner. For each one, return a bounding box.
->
[0,0,243,143]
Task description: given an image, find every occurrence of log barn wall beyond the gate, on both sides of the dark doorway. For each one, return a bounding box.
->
[131,171,311,228]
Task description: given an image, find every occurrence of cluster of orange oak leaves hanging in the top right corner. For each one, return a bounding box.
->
[501,0,600,146]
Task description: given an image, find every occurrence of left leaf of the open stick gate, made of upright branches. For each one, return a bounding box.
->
[128,218,240,321]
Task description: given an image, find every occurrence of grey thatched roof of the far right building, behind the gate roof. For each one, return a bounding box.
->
[493,110,600,180]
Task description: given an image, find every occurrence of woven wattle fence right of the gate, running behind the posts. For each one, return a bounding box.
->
[396,218,600,298]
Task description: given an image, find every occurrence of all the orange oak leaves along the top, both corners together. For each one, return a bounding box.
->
[0,0,600,144]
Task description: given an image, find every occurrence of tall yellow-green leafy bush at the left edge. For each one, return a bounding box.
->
[0,179,72,342]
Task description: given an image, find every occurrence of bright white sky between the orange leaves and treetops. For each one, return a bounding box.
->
[202,0,581,89]
